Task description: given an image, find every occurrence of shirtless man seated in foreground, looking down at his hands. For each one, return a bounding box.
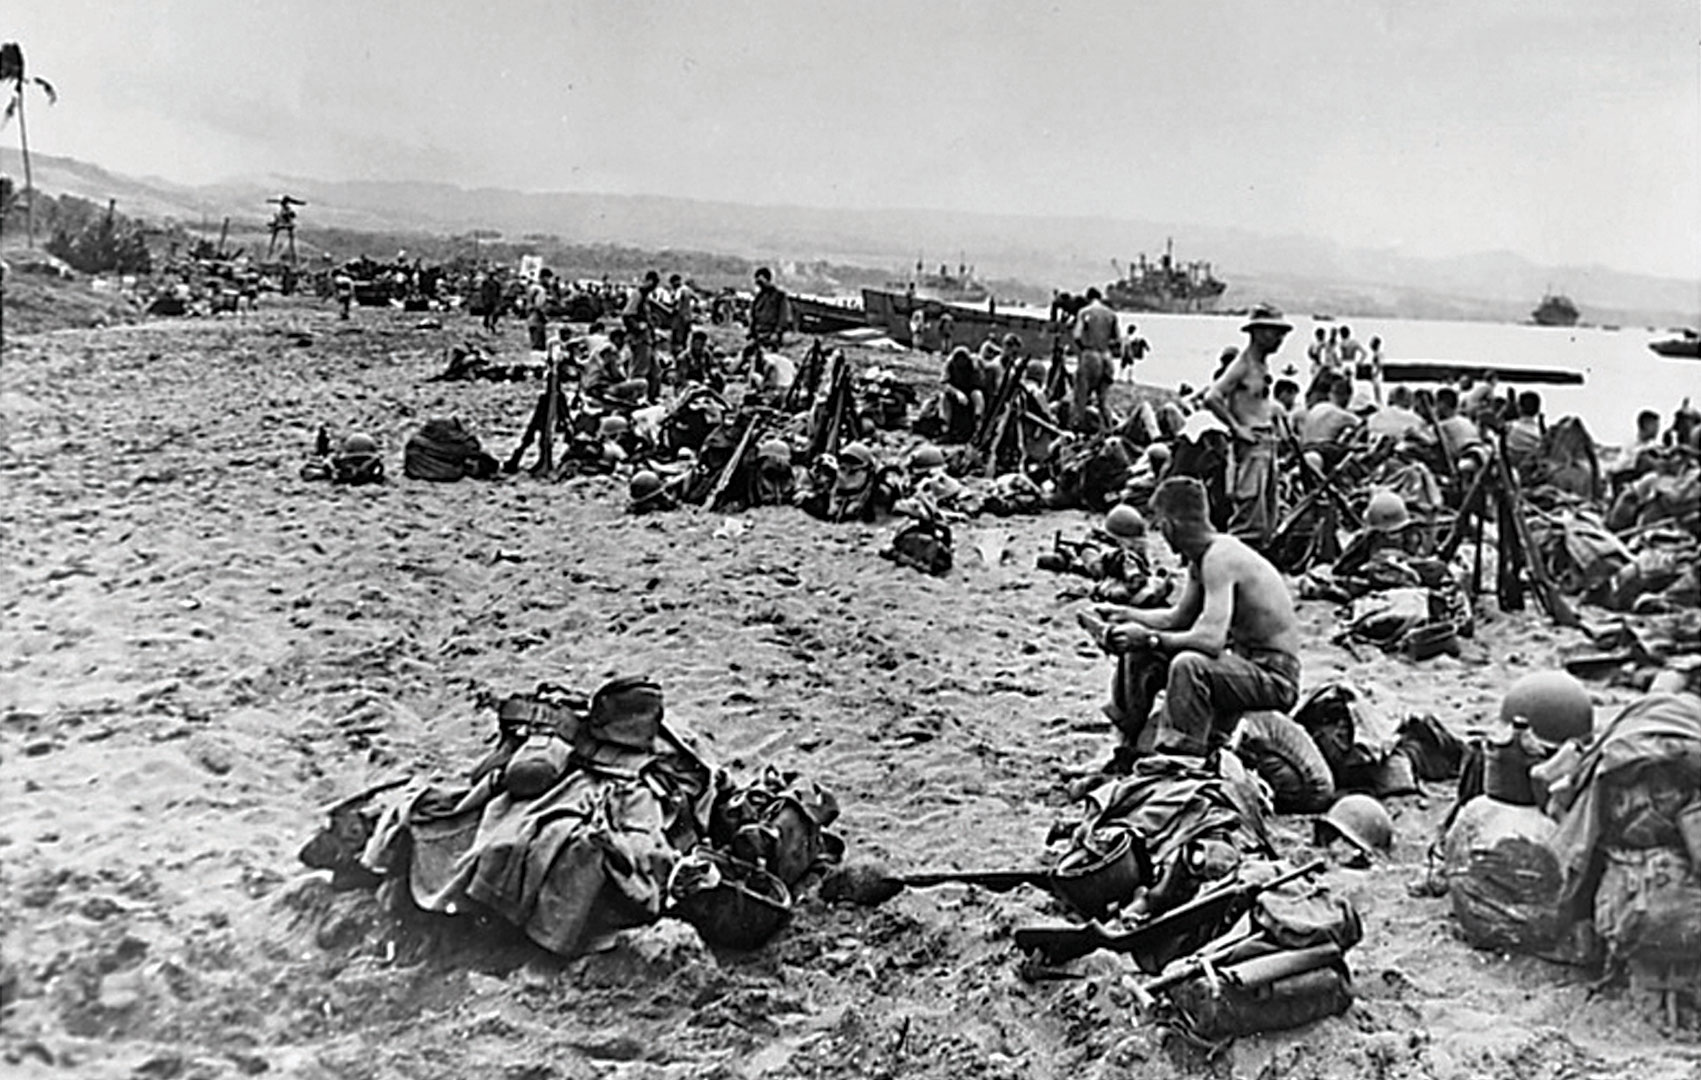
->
[1080,476,1300,772]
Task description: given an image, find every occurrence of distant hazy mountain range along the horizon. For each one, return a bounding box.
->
[0,150,1701,327]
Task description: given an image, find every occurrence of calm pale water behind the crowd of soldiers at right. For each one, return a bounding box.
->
[1102,315,1701,446]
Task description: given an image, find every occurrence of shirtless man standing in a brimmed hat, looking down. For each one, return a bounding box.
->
[1204,304,1293,549]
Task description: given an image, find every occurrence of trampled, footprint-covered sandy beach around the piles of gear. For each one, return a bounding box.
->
[0,297,1701,1080]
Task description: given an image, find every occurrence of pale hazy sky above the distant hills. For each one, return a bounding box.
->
[0,0,1701,277]
